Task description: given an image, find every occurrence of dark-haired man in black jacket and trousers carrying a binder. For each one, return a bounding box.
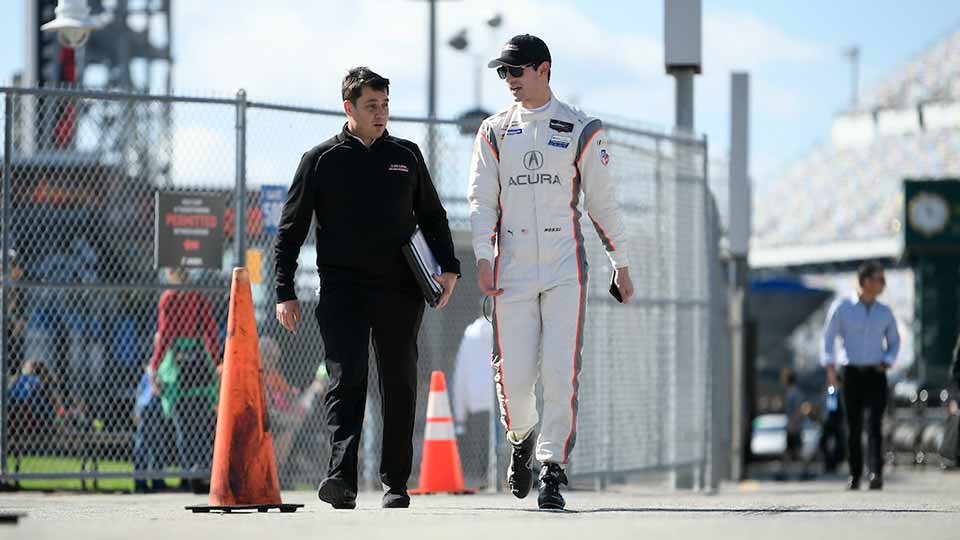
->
[276,67,460,508]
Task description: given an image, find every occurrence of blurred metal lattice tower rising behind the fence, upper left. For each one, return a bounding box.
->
[23,0,173,186]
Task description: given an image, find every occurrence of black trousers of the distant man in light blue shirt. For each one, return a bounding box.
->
[843,366,887,478]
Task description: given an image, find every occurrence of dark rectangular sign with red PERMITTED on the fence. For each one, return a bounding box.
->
[155,191,226,269]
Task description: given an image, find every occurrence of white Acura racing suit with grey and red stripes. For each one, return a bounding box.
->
[468,96,628,464]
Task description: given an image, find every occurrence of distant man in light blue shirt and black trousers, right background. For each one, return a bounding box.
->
[820,261,900,490]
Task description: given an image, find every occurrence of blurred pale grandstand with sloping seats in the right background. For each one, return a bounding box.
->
[750,29,960,268]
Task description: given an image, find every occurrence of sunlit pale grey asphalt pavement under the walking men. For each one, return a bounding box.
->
[0,468,960,540]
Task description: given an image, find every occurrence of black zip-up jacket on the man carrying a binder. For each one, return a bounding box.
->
[275,125,460,303]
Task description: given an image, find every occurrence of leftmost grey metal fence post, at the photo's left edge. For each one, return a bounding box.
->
[0,92,13,475]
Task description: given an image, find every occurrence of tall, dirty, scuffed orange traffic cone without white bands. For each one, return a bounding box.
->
[186,268,303,512]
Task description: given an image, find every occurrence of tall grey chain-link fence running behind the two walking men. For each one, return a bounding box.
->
[0,88,729,489]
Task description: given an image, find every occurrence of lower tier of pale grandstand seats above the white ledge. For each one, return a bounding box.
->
[752,128,960,247]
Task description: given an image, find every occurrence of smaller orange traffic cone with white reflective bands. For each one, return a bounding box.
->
[410,371,476,494]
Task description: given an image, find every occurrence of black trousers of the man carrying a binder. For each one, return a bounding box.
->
[316,283,424,490]
